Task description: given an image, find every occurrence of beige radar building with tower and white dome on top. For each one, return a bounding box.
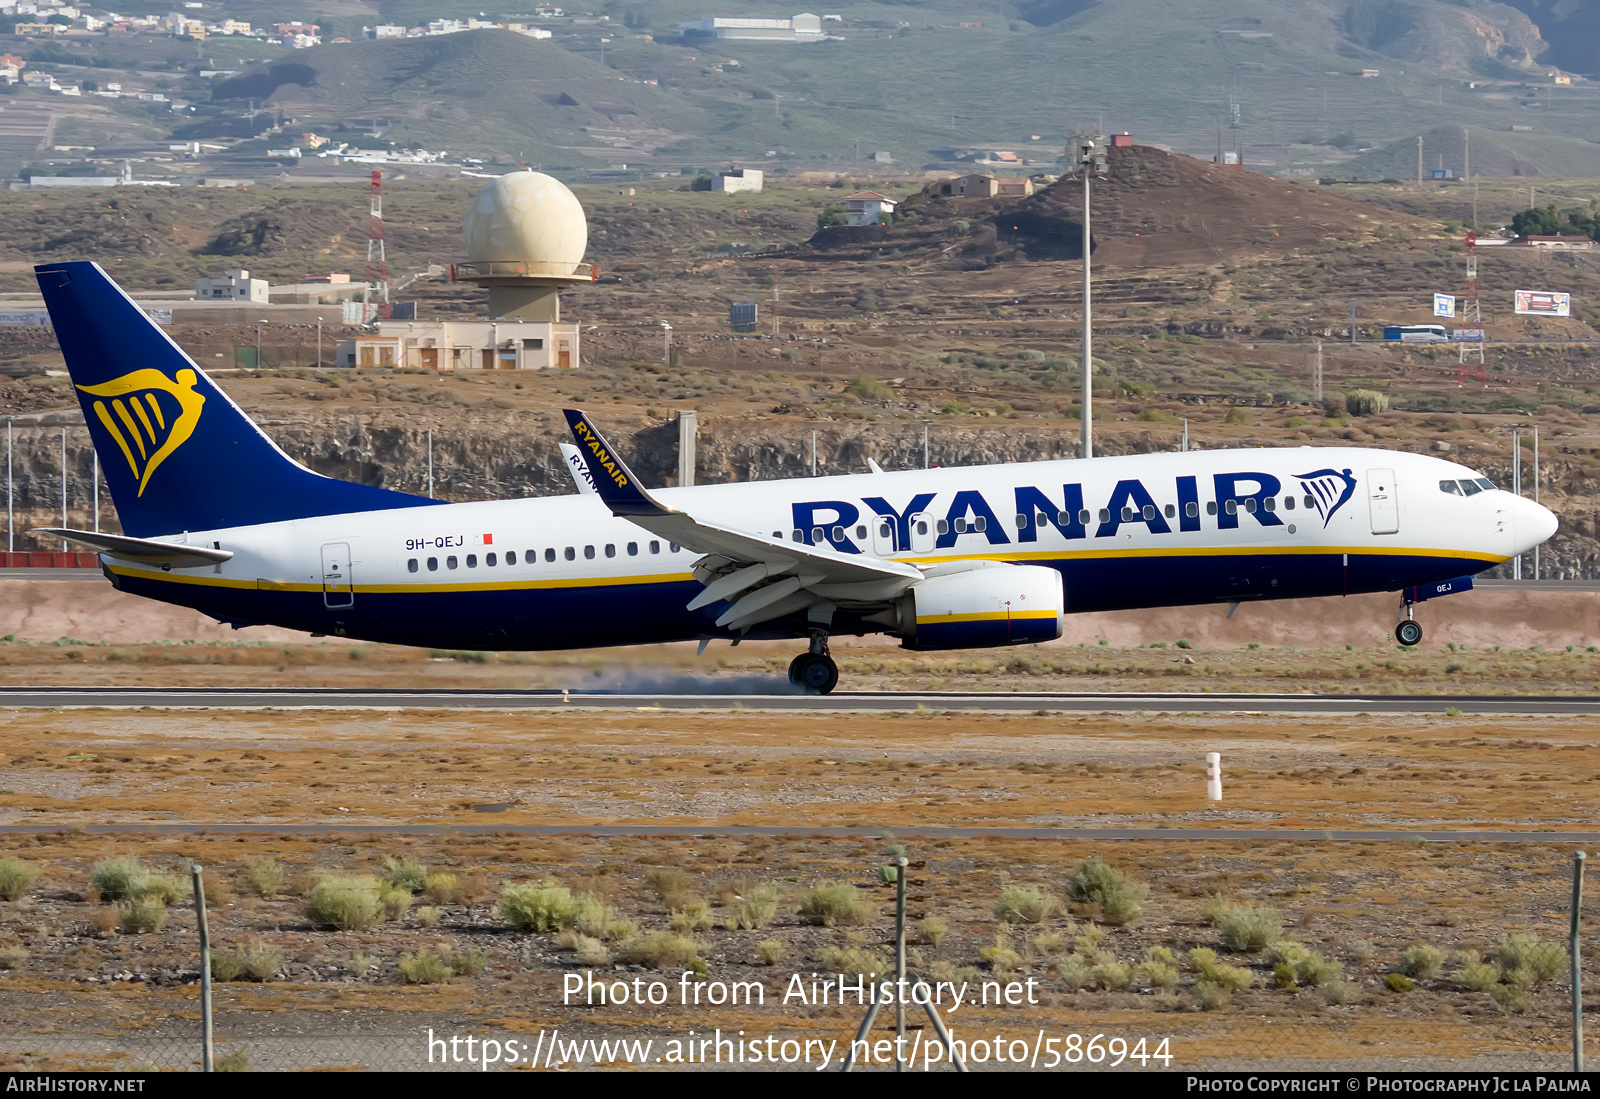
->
[348,171,595,370]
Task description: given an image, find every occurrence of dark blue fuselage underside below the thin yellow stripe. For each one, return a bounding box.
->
[106,552,1490,649]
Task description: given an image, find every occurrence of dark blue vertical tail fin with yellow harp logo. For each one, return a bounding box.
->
[34,262,438,538]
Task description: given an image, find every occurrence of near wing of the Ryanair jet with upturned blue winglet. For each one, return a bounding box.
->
[565,408,922,629]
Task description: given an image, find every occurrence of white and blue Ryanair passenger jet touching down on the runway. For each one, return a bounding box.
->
[37,262,1555,693]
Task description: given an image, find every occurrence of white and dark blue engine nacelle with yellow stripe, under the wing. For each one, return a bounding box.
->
[896,565,1066,649]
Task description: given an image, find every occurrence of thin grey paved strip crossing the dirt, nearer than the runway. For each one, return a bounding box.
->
[0,821,1600,843]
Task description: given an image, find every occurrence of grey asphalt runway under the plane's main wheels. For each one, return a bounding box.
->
[0,680,1600,715]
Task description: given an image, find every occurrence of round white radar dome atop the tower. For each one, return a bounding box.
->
[466,171,589,275]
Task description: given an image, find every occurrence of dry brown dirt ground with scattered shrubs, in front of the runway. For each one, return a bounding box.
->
[0,710,1600,1069]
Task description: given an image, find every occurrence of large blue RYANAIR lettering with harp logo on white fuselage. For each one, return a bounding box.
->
[792,469,1357,553]
